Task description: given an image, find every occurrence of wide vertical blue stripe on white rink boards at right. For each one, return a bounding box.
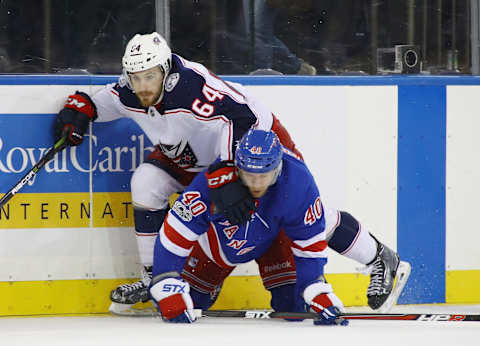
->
[397,85,446,304]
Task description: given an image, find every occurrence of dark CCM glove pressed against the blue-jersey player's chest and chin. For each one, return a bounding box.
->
[206,161,257,225]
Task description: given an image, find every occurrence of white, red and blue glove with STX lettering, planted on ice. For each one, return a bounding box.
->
[150,276,195,323]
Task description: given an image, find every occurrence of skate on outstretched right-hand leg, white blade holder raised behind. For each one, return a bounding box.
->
[367,241,411,313]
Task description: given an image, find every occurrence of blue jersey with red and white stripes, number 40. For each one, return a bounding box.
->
[153,149,327,288]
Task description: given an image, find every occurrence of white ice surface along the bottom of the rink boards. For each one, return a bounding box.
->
[0,305,480,346]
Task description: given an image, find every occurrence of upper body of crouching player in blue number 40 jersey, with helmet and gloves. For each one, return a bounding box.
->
[150,130,347,324]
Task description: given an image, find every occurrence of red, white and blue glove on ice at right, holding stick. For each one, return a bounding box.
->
[303,279,348,326]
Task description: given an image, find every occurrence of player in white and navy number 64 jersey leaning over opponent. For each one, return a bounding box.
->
[54,33,409,310]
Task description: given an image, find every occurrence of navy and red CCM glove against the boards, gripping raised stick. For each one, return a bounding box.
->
[53,91,97,146]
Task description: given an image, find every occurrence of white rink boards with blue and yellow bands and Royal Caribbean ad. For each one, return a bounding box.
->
[0,76,480,315]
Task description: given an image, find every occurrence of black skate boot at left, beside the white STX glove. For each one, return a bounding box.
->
[110,267,152,306]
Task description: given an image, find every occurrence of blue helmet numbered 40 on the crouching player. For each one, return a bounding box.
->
[235,129,283,173]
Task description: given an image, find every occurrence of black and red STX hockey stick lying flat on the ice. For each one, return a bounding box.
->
[201,310,480,322]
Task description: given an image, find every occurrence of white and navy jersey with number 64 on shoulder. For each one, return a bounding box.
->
[93,54,273,172]
